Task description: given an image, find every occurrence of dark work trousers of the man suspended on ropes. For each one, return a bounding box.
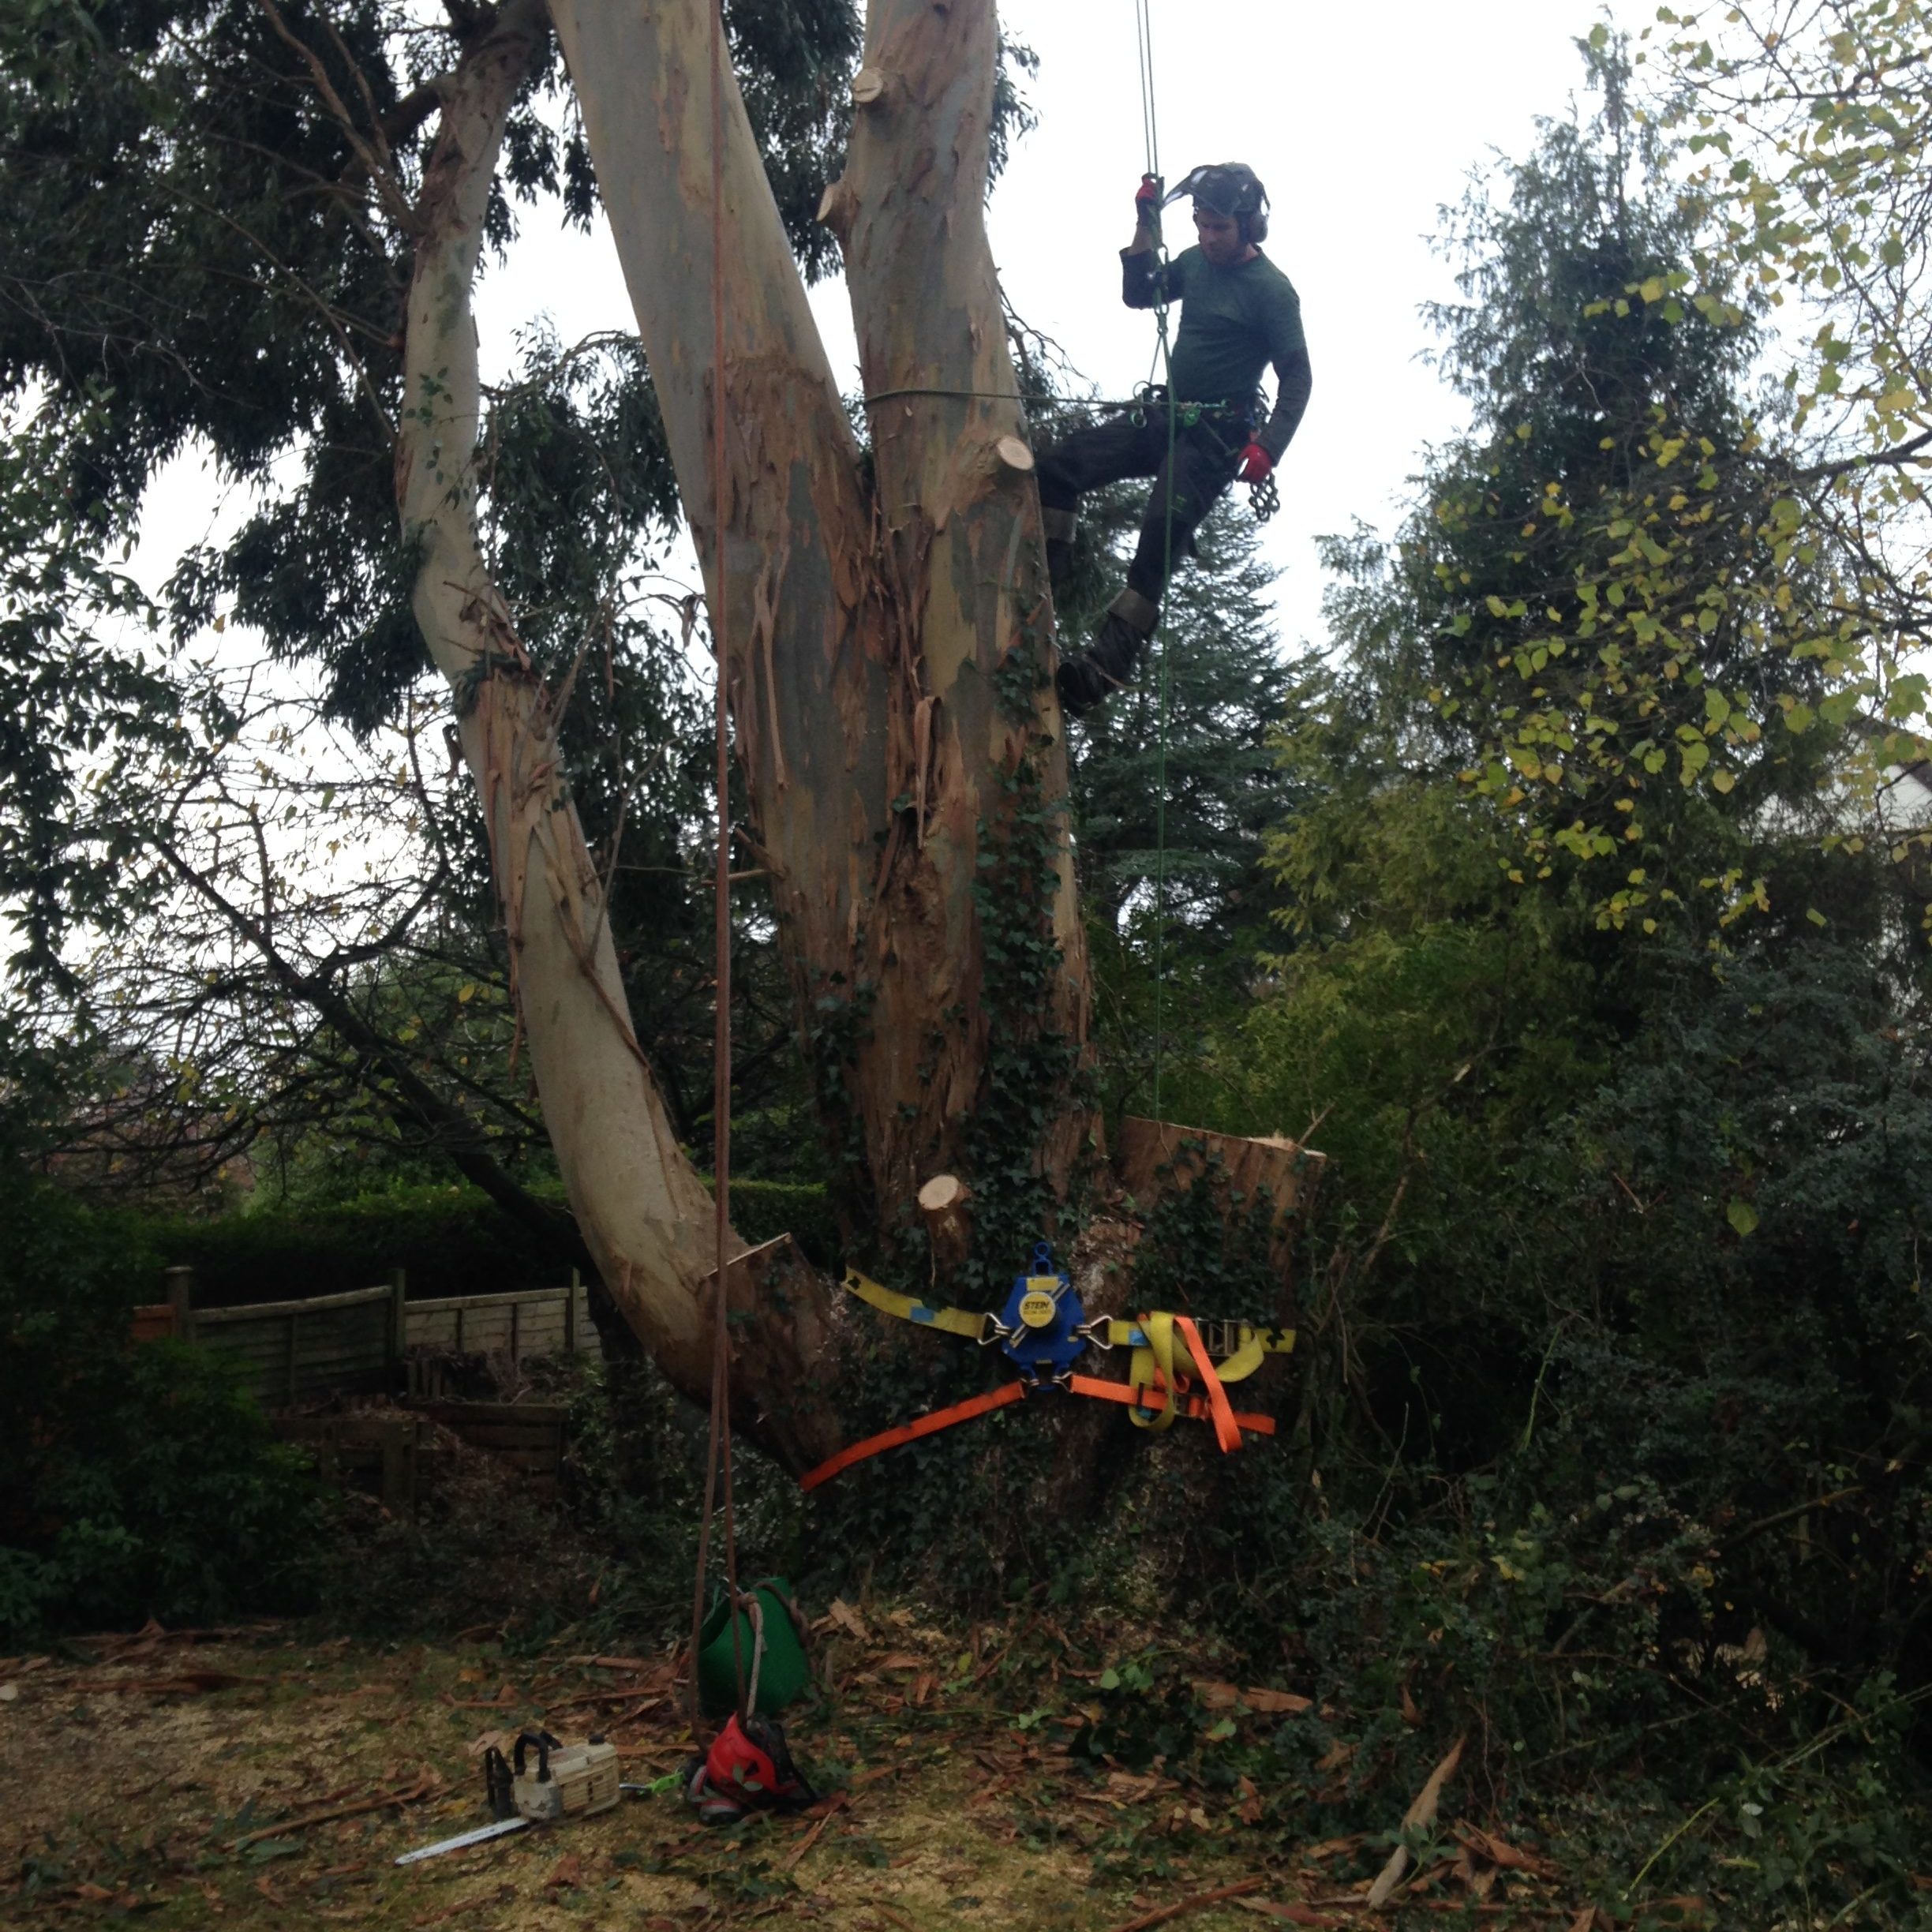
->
[1038,402,1248,605]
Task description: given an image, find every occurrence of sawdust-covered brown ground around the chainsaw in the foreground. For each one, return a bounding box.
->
[0,1605,1297,1932]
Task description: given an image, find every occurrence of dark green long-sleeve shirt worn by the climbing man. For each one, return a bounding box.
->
[1121,247,1314,462]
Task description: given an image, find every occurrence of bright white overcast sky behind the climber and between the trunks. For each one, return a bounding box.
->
[137,0,1629,650]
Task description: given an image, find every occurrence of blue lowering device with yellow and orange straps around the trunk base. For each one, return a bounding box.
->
[799,1242,1294,1489]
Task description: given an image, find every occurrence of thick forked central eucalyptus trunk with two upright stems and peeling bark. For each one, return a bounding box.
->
[551,0,1088,1241]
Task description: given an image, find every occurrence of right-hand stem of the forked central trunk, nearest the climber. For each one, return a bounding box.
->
[838,0,1088,1177]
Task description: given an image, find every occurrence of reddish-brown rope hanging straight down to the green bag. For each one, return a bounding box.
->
[690,0,755,1745]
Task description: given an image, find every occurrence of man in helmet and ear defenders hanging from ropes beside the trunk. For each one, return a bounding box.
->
[1039,163,1312,717]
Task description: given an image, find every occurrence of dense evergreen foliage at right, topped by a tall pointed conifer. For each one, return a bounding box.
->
[1136,45,1932,1924]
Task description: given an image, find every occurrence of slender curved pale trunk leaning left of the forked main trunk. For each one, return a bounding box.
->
[396,0,833,1462]
